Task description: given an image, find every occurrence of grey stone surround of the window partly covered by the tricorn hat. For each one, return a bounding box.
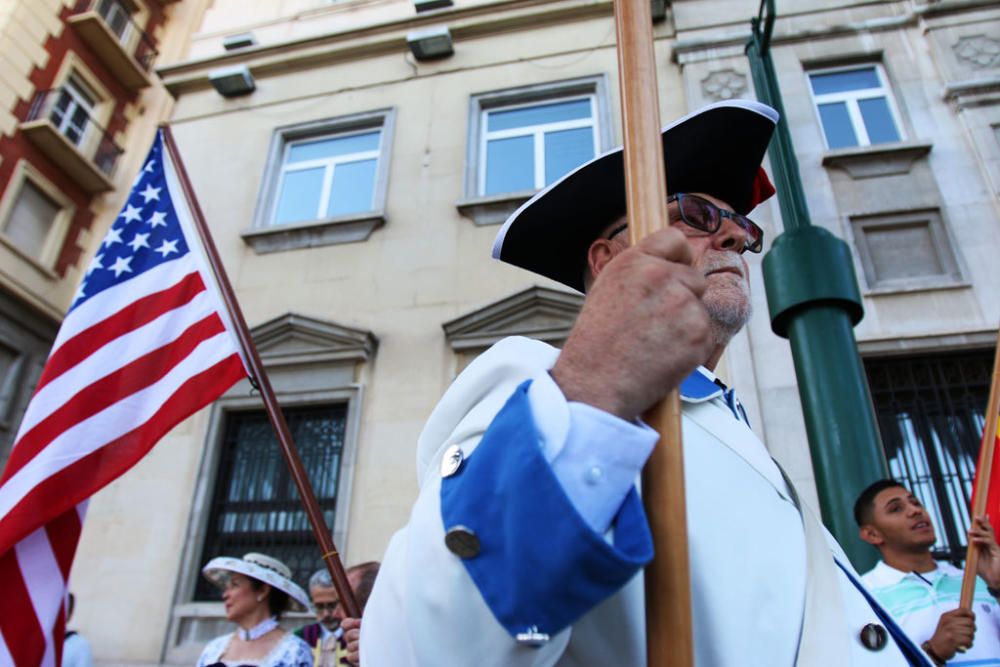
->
[465,74,612,201]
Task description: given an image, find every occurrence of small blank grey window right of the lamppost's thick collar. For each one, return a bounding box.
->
[851,210,962,289]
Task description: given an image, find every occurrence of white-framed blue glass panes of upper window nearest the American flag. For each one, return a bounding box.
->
[273,128,382,225]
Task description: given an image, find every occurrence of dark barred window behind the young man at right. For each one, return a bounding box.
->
[864,349,993,561]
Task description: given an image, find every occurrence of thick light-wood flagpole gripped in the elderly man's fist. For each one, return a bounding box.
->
[615,0,694,667]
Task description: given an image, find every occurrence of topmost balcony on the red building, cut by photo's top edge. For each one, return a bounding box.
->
[69,0,157,90]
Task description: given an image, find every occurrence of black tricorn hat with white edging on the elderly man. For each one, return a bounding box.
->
[493,100,778,292]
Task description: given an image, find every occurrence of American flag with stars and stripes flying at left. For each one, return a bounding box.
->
[0,131,246,667]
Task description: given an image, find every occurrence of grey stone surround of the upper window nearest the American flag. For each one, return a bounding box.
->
[241,107,396,254]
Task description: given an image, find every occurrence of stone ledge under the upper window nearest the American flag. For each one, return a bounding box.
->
[241,211,385,255]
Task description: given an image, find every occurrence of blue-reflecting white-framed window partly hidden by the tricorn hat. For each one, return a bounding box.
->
[479,95,599,195]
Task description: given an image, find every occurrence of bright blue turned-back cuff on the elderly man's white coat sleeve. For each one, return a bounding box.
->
[441,381,653,636]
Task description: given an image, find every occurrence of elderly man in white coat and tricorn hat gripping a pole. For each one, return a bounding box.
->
[361,101,930,667]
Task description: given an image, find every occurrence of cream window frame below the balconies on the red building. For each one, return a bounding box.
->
[0,159,76,272]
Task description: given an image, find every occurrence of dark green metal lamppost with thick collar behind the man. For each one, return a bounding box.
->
[746,0,888,570]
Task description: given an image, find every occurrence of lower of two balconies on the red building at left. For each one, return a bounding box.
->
[21,88,123,192]
